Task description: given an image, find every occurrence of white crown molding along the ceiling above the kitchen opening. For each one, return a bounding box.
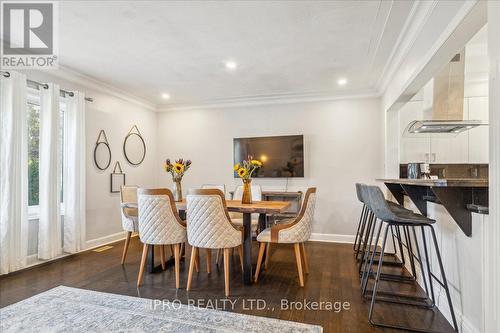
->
[375,0,438,94]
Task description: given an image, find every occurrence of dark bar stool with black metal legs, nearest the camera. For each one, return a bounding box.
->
[363,186,458,332]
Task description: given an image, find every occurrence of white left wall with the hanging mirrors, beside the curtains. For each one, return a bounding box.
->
[21,71,157,248]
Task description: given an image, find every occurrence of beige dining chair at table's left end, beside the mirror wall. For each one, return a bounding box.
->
[120,185,138,265]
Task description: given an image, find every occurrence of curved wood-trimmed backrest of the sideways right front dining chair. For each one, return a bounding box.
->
[271,187,316,243]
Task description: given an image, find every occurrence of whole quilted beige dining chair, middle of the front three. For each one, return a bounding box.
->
[186,189,243,296]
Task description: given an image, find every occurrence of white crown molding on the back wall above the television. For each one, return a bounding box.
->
[157,89,380,112]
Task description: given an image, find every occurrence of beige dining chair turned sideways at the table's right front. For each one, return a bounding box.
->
[255,187,316,287]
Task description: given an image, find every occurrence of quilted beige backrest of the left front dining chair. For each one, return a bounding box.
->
[138,189,186,245]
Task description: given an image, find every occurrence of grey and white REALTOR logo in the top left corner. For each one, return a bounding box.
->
[1,1,58,69]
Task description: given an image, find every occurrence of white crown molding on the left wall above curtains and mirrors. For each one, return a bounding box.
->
[47,65,156,111]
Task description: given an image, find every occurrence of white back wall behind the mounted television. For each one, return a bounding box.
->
[156,98,384,240]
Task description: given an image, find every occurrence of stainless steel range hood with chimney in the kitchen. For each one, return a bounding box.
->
[405,49,488,135]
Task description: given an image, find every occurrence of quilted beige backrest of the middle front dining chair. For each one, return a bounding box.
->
[186,189,242,249]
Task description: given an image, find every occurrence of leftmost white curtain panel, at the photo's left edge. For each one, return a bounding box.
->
[0,72,28,274]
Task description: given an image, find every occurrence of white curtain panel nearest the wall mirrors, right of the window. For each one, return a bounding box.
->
[63,92,85,253]
